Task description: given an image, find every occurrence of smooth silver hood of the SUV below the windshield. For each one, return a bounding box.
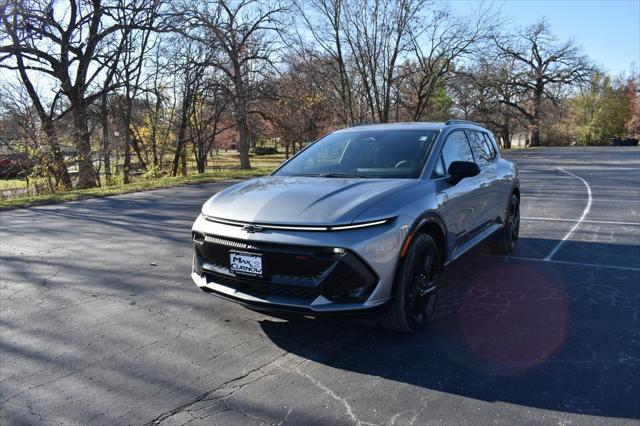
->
[202,176,417,225]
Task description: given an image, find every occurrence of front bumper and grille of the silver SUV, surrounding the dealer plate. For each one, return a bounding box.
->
[191,213,416,315]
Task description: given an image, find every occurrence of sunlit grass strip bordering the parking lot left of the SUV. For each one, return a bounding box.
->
[0,168,275,210]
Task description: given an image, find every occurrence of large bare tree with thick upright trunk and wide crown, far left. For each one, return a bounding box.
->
[0,0,165,188]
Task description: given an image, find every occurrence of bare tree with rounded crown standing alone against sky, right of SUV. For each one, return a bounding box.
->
[495,20,595,146]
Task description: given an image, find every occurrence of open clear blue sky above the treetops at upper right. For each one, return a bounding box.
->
[451,0,640,75]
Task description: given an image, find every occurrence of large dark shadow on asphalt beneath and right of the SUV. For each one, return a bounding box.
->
[261,241,640,419]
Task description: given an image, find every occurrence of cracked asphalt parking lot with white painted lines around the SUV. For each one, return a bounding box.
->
[0,148,640,425]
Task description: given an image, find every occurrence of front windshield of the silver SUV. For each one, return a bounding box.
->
[274,130,438,179]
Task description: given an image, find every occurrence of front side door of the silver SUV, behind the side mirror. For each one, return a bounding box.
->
[433,130,482,251]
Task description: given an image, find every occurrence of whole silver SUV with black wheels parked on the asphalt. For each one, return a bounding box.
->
[191,120,520,333]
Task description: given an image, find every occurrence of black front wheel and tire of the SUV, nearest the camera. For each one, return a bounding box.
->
[378,234,442,334]
